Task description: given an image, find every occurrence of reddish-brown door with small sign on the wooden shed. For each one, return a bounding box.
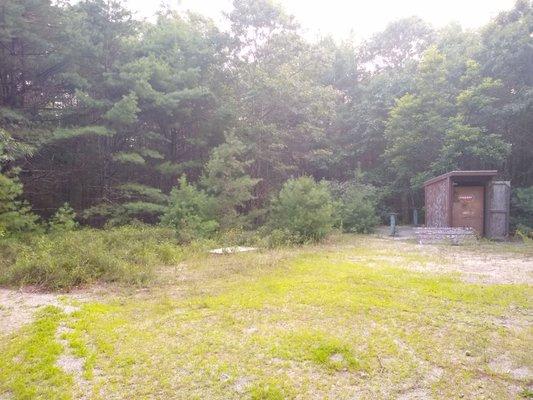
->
[452,186,485,235]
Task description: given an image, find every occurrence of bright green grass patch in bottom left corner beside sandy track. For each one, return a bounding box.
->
[0,306,72,399]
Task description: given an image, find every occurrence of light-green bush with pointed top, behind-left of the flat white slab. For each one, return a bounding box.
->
[161,175,218,242]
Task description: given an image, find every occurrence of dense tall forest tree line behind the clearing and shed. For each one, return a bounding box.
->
[0,0,533,230]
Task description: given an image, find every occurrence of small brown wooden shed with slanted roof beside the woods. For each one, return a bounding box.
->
[424,170,511,239]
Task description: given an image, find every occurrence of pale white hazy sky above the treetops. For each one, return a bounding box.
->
[126,0,515,39]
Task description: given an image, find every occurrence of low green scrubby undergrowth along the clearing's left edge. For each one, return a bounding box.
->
[0,226,183,290]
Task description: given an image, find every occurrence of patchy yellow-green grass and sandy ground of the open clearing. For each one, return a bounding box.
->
[0,236,533,399]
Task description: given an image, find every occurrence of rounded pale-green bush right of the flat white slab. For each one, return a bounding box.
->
[269,177,334,243]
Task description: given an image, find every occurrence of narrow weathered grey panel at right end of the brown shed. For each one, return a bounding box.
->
[486,181,511,240]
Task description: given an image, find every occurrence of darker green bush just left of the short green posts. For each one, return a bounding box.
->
[338,183,379,233]
